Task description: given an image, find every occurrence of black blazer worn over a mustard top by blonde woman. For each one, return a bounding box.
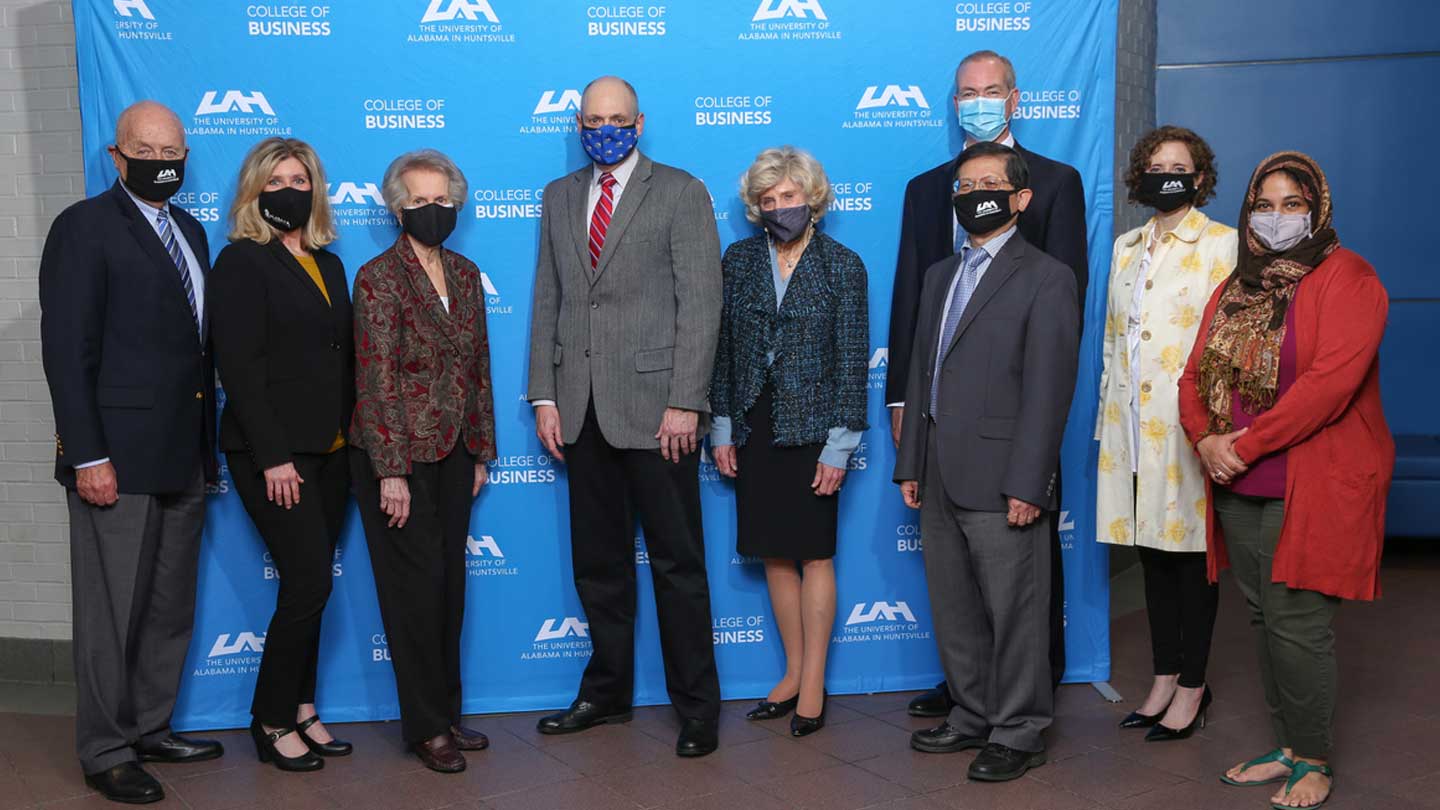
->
[210,239,356,470]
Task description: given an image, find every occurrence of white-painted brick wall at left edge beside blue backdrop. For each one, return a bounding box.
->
[0,0,84,638]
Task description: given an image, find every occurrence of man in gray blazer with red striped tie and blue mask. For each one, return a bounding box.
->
[527,76,721,757]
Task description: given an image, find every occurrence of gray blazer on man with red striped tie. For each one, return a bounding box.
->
[526,154,723,450]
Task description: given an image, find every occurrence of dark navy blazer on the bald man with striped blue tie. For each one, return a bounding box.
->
[40,183,216,494]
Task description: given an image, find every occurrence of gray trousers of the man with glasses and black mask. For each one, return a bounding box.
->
[920,440,1056,751]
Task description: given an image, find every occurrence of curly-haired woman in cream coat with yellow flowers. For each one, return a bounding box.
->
[1096,127,1237,741]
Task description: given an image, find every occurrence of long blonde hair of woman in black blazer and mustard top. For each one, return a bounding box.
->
[230,138,336,249]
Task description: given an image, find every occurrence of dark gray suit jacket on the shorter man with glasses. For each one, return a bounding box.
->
[894,233,1080,512]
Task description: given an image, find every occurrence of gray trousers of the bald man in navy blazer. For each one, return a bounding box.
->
[66,470,204,774]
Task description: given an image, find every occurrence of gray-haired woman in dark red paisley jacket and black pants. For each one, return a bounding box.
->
[350,150,495,773]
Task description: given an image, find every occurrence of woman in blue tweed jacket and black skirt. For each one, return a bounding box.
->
[710,147,870,736]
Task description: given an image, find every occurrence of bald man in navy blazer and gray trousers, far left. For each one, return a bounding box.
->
[40,101,222,803]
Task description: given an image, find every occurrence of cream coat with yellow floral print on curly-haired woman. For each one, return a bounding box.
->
[1094,204,1237,552]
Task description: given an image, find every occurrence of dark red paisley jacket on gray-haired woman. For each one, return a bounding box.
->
[350,235,495,477]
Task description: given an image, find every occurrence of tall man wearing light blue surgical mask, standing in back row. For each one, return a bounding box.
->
[886,50,1089,718]
